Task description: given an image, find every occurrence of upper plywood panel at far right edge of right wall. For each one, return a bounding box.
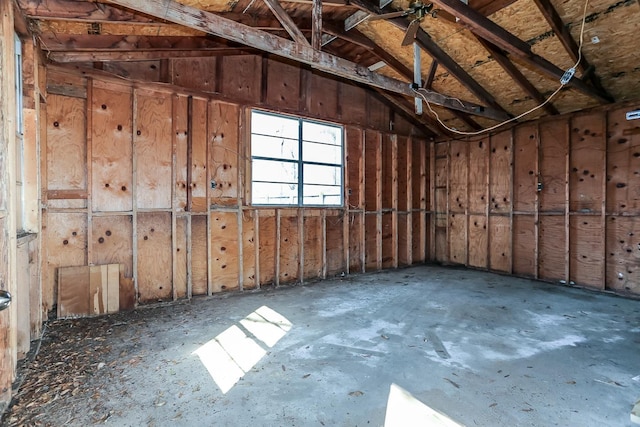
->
[607,108,640,215]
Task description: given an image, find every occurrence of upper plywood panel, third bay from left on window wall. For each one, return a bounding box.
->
[133,90,173,209]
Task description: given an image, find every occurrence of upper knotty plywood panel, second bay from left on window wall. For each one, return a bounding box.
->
[91,81,133,212]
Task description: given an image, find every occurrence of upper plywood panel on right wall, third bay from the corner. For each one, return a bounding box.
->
[468,138,489,214]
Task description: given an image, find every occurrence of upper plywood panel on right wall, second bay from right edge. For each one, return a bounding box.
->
[569,113,606,213]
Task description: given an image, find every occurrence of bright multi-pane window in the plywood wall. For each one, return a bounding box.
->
[251,111,343,206]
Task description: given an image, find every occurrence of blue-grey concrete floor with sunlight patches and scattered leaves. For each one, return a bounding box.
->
[5,266,640,426]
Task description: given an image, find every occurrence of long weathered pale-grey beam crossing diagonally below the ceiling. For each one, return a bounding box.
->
[104,0,502,120]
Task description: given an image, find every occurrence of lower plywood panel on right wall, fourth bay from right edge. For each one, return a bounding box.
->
[512,215,537,277]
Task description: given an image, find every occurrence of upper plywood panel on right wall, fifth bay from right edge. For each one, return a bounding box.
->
[489,130,512,213]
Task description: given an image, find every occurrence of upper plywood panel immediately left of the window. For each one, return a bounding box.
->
[209,101,240,205]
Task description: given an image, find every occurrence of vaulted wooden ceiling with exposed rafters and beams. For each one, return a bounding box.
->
[15,0,640,135]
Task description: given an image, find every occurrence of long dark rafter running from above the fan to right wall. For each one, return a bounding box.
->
[433,0,613,103]
